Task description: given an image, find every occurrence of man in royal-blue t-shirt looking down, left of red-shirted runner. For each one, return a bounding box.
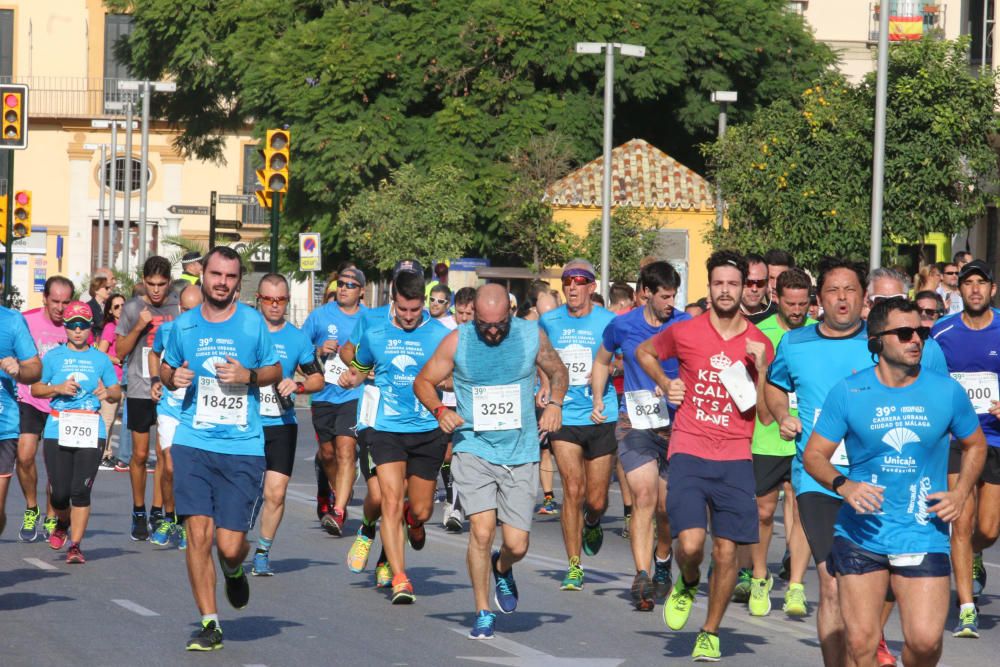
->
[590,262,691,611]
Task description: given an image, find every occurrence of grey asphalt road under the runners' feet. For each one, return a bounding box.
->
[0,410,1000,667]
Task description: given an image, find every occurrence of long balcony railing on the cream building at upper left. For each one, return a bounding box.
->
[0,76,137,118]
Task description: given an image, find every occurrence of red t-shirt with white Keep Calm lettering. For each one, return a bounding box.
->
[653,313,774,461]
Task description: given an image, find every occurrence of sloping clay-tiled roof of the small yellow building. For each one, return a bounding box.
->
[543,139,715,209]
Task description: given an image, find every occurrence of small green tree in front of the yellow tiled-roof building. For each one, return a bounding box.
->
[583,206,662,282]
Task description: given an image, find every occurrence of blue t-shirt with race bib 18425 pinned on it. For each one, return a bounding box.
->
[164,303,278,456]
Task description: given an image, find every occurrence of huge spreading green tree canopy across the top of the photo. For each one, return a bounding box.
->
[105,0,833,272]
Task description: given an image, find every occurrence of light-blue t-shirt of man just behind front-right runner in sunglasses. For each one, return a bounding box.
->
[767,322,948,497]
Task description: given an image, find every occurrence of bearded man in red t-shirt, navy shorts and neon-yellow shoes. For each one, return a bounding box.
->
[635,250,774,660]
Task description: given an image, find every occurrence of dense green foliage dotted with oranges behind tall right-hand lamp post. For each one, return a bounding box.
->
[707,39,1000,266]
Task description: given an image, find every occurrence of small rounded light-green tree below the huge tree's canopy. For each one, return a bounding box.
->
[342,164,472,271]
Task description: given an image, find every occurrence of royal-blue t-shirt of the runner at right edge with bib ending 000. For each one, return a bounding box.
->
[931,313,1000,447]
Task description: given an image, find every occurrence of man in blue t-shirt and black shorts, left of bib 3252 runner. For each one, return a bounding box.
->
[340,271,448,604]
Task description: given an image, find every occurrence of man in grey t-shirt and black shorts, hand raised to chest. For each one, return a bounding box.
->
[115,255,180,542]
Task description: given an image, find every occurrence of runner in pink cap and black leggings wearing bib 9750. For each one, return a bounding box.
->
[31,301,122,563]
